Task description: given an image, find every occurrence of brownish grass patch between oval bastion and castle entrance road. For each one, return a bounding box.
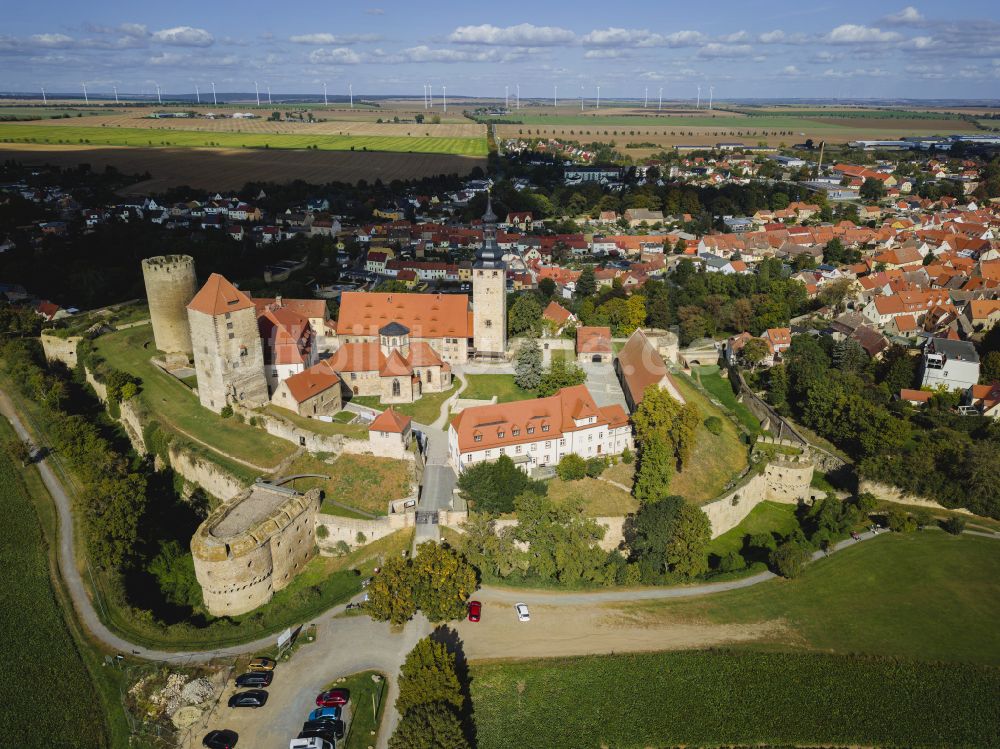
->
[288,453,413,515]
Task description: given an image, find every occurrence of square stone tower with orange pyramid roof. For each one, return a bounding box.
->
[187,273,268,413]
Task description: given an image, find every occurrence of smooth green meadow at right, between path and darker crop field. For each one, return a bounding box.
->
[632,530,1000,666]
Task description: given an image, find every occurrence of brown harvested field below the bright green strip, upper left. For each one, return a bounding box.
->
[0,143,486,190]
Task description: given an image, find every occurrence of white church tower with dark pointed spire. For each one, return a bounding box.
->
[472,191,507,359]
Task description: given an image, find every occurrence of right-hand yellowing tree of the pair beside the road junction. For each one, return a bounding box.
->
[411,541,478,622]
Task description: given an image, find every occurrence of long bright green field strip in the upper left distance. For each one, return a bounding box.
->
[0,124,487,156]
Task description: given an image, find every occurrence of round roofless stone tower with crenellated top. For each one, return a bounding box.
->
[142,255,198,356]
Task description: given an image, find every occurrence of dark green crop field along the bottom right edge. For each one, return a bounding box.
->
[471,648,1000,749]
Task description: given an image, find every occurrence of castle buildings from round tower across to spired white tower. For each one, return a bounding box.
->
[143,203,507,416]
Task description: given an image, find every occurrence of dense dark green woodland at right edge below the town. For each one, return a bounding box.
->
[761,335,1000,518]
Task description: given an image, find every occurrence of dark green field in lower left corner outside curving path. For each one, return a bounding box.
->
[0,421,110,747]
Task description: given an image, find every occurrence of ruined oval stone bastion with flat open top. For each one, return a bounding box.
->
[191,483,320,616]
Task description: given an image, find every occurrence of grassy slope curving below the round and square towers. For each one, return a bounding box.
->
[94,325,295,468]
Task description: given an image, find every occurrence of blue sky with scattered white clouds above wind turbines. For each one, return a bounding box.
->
[0,0,1000,101]
